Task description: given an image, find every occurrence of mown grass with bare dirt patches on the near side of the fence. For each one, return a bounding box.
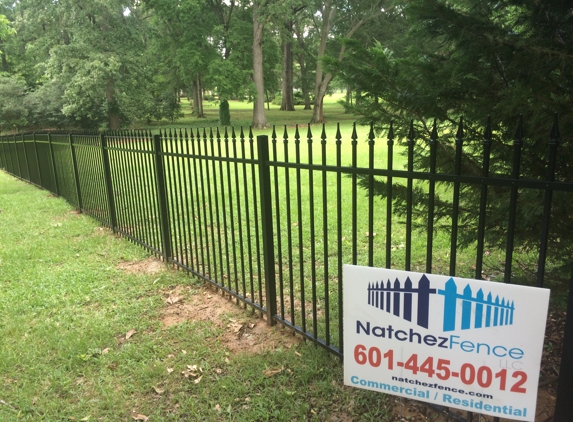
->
[0,173,389,421]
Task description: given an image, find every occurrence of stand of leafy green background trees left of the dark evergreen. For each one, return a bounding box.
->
[0,0,392,130]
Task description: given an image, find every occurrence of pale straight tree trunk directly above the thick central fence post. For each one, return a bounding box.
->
[252,1,269,129]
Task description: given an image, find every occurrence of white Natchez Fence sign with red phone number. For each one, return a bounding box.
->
[343,265,549,421]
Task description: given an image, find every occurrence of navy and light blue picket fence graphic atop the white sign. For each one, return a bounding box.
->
[367,274,515,332]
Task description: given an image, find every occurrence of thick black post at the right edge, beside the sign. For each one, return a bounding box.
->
[553,271,573,422]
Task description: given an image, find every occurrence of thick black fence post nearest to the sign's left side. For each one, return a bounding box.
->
[257,135,277,326]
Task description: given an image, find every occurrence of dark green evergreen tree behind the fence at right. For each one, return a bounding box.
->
[329,0,573,280]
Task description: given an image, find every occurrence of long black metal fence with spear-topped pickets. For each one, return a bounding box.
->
[0,120,573,420]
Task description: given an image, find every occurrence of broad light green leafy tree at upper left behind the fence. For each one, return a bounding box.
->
[8,0,155,129]
